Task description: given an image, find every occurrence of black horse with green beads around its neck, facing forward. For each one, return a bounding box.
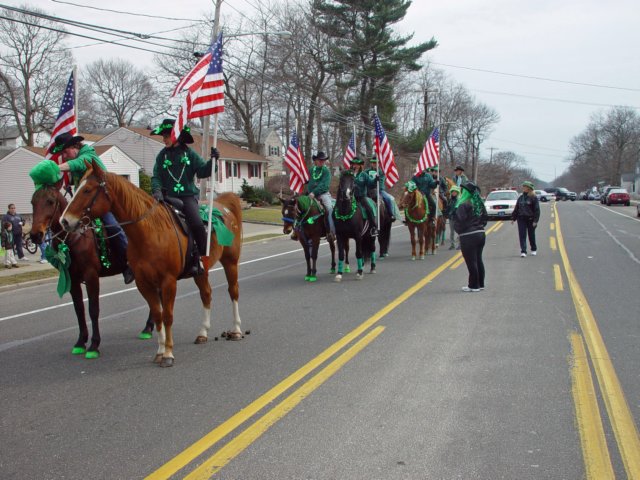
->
[333,170,376,282]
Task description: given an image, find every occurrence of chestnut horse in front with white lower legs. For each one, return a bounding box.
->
[61,162,243,367]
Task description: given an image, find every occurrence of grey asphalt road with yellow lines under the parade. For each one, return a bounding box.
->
[0,202,640,479]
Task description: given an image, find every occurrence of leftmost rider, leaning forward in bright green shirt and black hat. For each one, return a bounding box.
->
[49,132,134,283]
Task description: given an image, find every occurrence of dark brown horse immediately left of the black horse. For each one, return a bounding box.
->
[278,195,348,283]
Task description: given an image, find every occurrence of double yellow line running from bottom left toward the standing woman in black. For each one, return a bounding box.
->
[146,224,497,480]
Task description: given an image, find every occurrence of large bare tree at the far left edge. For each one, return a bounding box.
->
[0,7,73,146]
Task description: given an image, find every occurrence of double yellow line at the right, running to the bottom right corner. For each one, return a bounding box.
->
[554,205,640,480]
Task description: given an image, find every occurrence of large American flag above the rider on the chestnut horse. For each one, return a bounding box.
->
[171,34,224,141]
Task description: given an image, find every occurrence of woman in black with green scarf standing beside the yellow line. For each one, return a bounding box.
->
[453,182,488,292]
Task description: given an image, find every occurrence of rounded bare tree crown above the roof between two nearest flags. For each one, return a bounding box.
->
[84,59,161,127]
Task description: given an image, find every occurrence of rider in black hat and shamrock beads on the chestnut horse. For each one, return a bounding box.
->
[151,118,220,273]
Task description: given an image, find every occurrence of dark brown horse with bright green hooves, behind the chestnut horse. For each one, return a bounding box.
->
[29,182,153,359]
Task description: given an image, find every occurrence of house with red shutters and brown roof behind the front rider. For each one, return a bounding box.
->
[93,127,268,193]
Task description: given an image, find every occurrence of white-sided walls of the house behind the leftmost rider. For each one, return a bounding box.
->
[0,145,140,216]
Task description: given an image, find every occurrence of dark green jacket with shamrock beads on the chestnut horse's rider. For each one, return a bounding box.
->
[151,145,212,197]
